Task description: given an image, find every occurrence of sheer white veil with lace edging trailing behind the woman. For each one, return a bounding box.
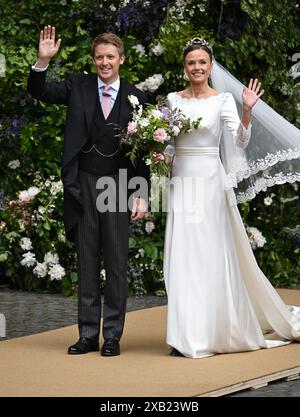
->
[211,60,300,203]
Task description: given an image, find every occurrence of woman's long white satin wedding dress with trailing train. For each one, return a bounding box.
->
[164,93,300,358]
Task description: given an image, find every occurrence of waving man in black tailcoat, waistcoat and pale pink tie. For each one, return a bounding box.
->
[28,26,149,356]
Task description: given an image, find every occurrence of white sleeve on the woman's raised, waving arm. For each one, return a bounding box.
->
[221,93,251,149]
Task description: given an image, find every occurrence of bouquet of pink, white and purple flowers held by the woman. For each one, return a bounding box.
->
[121,95,201,176]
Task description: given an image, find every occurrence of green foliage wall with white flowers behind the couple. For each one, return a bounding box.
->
[0,0,300,295]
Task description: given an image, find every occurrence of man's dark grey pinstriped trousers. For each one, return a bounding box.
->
[75,171,129,340]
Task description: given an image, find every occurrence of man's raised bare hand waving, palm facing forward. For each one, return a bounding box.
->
[37,25,61,67]
